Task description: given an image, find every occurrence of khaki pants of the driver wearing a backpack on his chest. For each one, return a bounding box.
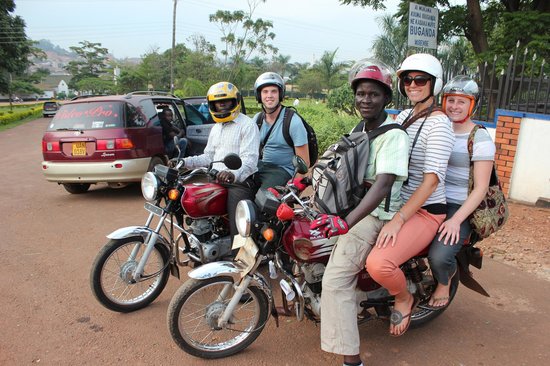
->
[321,215,386,356]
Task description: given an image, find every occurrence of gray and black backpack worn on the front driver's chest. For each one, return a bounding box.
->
[312,123,403,217]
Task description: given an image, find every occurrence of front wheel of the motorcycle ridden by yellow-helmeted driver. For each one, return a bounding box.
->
[90,237,170,313]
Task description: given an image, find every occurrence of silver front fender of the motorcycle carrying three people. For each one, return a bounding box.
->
[187,261,273,304]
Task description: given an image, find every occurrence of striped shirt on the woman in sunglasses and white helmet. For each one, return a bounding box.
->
[395,109,455,206]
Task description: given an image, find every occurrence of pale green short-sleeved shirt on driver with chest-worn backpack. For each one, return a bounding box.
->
[365,115,409,220]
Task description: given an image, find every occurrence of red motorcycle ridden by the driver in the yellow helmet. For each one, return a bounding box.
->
[90,144,241,312]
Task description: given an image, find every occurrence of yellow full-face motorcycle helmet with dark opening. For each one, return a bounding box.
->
[206,81,241,123]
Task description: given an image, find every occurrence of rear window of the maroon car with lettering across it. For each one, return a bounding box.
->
[48,102,124,131]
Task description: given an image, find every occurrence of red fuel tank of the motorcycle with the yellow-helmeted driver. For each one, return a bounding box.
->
[181,183,227,219]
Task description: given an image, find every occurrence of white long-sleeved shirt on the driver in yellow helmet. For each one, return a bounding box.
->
[184,114,260,182]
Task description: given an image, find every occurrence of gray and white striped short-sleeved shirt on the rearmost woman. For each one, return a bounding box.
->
[445,128,496,205]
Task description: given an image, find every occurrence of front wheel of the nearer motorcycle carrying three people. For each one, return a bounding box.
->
[167,277,269,359]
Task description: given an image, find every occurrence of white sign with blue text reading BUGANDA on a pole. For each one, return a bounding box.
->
[408,3,439,49]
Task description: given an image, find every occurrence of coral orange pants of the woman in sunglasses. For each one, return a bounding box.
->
[367,208,446,295]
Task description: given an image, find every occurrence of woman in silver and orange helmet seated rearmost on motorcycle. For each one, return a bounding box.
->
[428,75,496,309]
